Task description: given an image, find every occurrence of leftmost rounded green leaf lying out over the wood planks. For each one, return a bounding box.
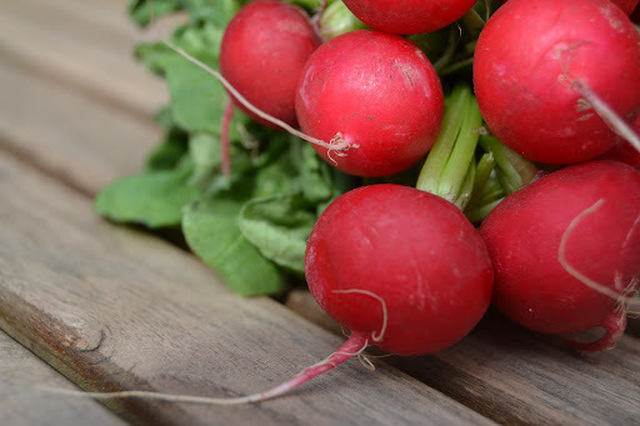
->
[94,160,202,228]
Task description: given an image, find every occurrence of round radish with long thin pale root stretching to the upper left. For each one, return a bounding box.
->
[296,30,444,176]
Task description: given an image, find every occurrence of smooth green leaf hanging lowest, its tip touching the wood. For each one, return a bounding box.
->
[182,198,286,296]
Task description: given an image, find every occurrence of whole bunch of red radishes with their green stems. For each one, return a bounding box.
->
[81,0,640,403]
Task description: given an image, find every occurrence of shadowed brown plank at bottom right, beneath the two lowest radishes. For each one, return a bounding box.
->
[287,291,640,425]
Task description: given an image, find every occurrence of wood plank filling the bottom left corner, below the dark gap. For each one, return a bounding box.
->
[0,331,125,426]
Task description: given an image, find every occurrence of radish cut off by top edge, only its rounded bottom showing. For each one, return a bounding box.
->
[343,0,476,34]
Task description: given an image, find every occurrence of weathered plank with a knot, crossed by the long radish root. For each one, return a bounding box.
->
[0,151,496,424]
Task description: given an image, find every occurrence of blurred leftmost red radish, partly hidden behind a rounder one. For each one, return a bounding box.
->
[220,0,320,126]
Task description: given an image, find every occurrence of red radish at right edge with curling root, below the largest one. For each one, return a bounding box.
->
[480,161,640,350]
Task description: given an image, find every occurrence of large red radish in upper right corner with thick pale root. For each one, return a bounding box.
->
[473,0,640,164]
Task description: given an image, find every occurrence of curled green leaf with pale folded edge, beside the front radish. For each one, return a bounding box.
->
[239,195,317,273]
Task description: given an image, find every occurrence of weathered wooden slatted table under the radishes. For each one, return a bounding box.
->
[0,0,640,426]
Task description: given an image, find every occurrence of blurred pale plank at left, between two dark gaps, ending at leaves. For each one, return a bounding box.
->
[0,61,161,194]
